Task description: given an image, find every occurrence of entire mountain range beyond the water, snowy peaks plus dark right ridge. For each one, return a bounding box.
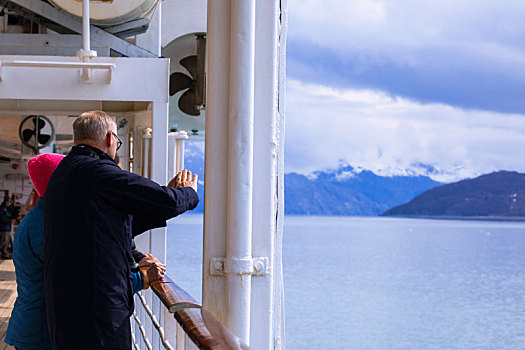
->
[185,142,525,217]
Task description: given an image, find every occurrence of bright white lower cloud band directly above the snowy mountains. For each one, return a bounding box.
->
[285,79,525,181]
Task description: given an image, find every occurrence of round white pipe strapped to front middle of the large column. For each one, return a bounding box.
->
[225,0,255,344]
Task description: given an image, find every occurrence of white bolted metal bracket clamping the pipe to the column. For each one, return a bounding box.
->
[210,257,268,276]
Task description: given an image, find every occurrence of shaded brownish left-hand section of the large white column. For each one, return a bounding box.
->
[202,0,230,322]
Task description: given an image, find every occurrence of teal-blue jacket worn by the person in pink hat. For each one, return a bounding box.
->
[5,198,142,349]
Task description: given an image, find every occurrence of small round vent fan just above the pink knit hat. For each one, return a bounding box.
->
[18,115,55,152]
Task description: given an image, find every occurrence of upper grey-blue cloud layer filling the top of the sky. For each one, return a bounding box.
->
[287,0,525,113]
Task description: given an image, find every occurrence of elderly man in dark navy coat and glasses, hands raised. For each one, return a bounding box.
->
[44,111,199,349]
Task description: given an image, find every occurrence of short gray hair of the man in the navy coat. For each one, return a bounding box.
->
[73,111,116,144]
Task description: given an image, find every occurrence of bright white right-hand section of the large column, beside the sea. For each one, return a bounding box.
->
[250,0,285,349]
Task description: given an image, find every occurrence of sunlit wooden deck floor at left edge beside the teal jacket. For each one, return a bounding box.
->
[0,260,16,350]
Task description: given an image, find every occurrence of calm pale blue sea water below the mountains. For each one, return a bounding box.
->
[168,215,525,349]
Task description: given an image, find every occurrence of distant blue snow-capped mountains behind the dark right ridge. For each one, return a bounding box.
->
[185,142,441,216]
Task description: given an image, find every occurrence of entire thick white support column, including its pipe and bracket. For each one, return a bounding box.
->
[203,0,286,350]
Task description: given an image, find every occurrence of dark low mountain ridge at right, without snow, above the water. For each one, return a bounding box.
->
[382,171,525,217]
